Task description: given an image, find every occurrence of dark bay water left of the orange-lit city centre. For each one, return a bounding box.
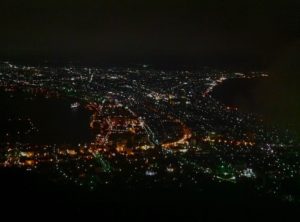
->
[0,91,92,145]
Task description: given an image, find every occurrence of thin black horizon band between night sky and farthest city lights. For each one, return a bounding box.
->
[0,55,269,72]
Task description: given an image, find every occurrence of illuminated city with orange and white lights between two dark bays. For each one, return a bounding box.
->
[0,62,300,203]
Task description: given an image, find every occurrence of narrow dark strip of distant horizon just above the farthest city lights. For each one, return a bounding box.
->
[0,56,266,71]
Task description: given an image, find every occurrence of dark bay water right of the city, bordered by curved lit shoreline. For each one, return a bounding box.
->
[212,78,300,135]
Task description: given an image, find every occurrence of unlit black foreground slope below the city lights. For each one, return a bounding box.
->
[0,169,298,221]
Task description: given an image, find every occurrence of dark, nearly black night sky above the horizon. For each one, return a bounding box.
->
[0,0,300,65]
